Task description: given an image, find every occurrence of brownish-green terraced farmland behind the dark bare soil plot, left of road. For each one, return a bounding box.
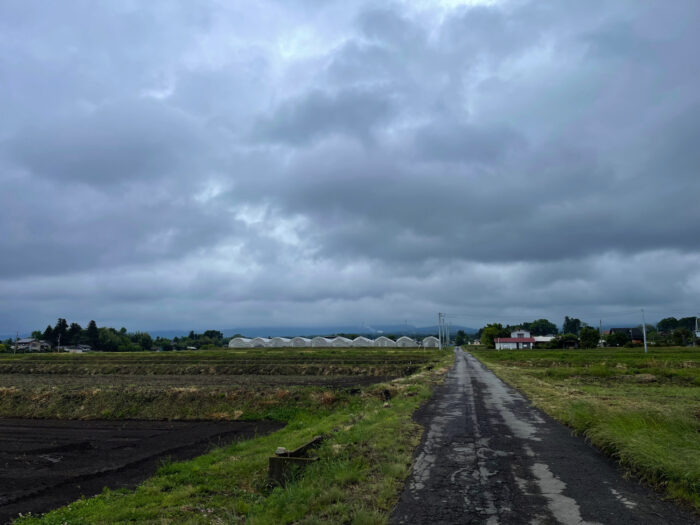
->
[0,348,440,421]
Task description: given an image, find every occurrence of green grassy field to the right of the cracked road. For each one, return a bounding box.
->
[472,348,700,510]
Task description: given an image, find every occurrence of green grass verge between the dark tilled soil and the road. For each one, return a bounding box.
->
[17,353,453,525]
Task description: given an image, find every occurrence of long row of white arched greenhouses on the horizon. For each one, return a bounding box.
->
[228,335,440,348]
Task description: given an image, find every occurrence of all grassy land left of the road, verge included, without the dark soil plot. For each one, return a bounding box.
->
[0,349,453,524]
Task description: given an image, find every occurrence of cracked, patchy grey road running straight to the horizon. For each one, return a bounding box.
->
[391,349,698,525]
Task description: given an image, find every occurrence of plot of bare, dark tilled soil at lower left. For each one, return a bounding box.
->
[0,419,283,523]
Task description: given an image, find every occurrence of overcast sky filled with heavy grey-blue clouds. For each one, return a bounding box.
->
[0,0,700,332]
